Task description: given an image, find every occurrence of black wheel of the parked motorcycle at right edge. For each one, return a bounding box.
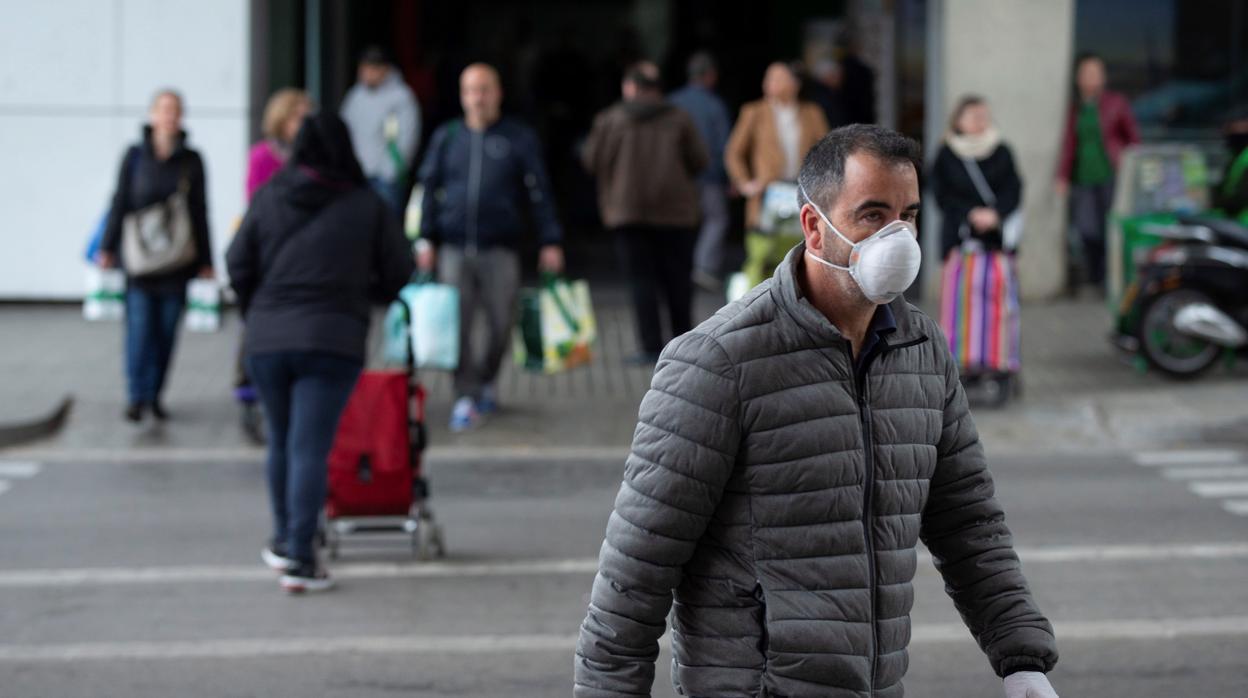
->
[1138,288,1222,378]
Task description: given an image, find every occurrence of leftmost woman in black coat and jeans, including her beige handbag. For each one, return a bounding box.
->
[97,90,212,422]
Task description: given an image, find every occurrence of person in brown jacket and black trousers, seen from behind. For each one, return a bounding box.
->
[582,62,709,363]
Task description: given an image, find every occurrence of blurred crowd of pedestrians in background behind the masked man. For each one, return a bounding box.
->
[90,42,1248,586]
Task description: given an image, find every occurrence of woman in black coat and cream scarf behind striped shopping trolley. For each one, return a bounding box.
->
[929,95,1022,260]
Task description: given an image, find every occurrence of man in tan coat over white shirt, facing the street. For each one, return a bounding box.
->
[724,62,829,286]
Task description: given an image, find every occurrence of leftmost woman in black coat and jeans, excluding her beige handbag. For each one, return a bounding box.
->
[97,90,212,422]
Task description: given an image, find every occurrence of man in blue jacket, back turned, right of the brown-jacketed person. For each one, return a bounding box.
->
[668,51,733,291]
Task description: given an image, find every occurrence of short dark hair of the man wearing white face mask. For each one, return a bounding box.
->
[797,124,922,209]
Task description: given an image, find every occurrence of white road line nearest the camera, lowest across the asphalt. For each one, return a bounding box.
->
[0,616,1248,663]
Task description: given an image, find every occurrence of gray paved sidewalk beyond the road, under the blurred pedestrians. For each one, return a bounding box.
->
[0,285,1248,457]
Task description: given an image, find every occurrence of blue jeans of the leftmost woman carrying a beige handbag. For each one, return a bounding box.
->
[126,286,186,405]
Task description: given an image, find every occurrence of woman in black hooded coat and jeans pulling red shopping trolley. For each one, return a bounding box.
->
[226,112,413,592]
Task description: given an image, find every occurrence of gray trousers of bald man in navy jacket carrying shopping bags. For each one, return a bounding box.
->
[438,246,520,402]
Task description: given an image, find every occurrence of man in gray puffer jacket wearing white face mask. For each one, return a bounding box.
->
[575,125,1057,698]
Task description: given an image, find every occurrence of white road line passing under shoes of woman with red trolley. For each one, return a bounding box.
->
[0,542,1248,588]
